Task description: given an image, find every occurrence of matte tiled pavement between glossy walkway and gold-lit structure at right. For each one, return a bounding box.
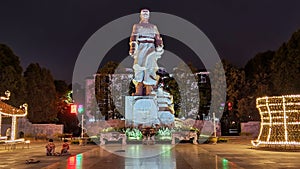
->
[201,137,300,169]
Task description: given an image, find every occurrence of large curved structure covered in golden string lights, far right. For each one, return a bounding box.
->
[251,95,300,146]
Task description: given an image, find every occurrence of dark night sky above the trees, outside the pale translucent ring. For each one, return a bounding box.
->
[0,0,300,83]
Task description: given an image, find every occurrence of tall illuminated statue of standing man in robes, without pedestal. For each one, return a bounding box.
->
[129,9,164,96]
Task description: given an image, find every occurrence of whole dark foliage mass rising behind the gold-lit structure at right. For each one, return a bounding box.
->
[238,30,300,121]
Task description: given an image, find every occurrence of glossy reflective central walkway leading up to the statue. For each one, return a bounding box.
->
[59,144,241,169]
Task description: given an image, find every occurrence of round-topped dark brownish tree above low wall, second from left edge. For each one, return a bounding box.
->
[24,63,57,123]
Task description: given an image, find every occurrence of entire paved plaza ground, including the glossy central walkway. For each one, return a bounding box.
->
[0,137,300,169]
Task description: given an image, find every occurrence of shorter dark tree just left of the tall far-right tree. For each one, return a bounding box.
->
[243,51,275,121]
